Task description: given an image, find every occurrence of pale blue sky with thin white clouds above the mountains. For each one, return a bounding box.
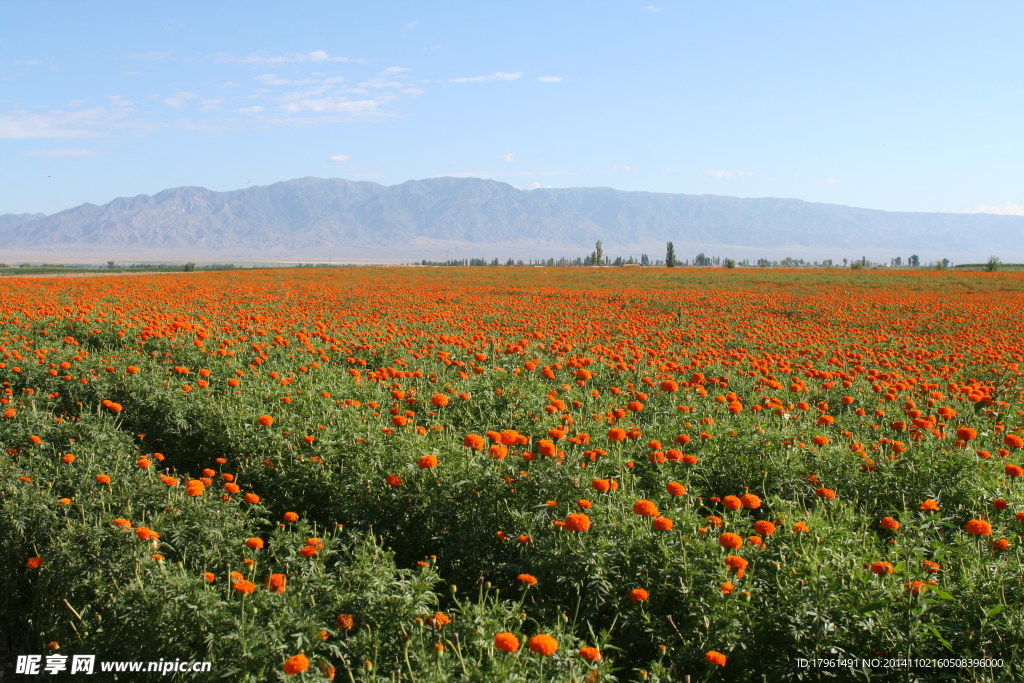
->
[0,0,1024,213]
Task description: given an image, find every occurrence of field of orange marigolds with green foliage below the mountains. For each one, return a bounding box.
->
[0,267,1024,683]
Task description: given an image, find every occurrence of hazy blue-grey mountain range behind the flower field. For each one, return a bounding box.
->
[0,178,1024,262]
